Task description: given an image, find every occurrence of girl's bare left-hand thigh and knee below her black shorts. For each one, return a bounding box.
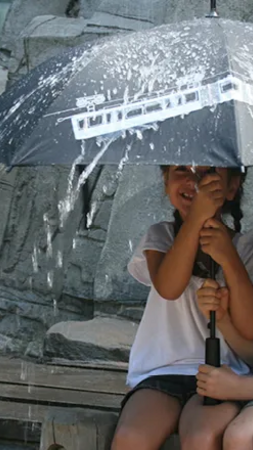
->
[111,389,181,450]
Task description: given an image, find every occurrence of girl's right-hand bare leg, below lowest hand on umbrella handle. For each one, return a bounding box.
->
[179,395,239,450]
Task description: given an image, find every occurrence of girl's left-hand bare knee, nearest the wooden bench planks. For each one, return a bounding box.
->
[111,427,150,450]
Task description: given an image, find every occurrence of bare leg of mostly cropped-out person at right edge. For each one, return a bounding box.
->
[223,406,253,450]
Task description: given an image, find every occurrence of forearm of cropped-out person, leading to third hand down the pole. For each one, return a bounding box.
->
[217,315,253,366]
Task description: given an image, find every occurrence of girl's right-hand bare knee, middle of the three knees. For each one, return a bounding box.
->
[180,429,221,450]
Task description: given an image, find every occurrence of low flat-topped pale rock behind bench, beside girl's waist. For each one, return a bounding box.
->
[44,317,137,362]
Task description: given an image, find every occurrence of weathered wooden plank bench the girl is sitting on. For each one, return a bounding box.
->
[0,358,179,450]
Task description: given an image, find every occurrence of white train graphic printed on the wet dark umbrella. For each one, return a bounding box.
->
[45,75,253,140]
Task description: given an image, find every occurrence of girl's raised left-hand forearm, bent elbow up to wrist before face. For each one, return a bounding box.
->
[154,214,203,300]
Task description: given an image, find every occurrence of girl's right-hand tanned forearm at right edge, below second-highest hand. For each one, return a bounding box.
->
[222,250,253,339]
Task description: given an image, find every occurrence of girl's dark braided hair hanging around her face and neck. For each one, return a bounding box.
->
[161,166,247,278]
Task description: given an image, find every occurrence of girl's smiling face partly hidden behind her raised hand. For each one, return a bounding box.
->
[164,166,240,220]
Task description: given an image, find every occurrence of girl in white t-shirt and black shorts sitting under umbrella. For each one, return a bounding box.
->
[112,166,253,450]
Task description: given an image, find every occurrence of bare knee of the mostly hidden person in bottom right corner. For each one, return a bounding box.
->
[223,422,253,450]
